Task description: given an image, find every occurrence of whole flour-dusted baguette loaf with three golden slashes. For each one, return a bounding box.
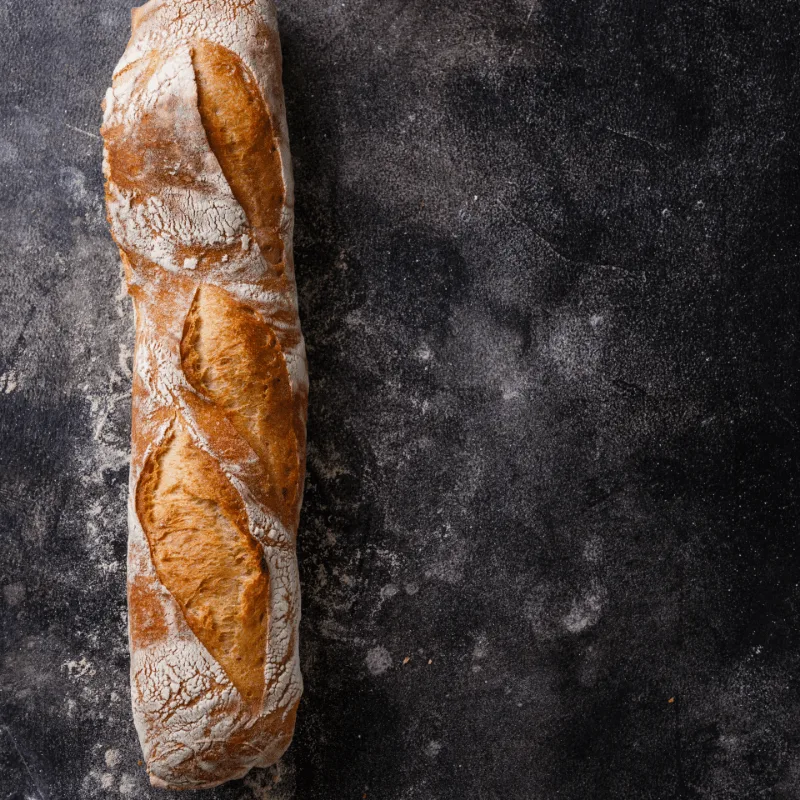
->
[97,0,308,789]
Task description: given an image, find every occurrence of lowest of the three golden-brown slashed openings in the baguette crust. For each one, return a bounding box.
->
[136,426,269,708]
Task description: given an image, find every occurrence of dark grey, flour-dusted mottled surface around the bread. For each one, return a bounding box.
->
[0,0,800,800]
